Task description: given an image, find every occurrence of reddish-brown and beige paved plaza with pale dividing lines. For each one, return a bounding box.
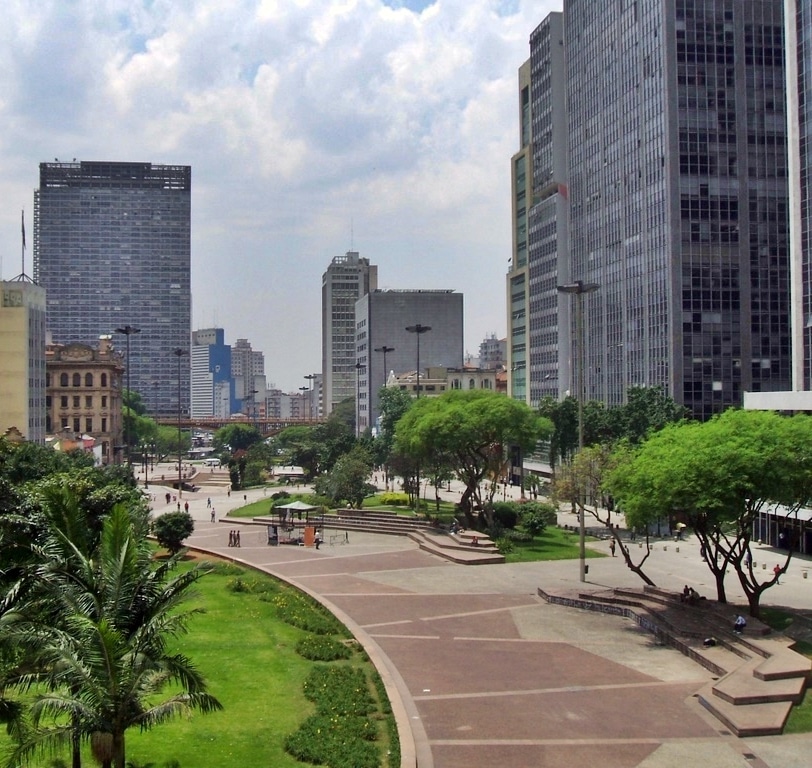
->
[151,468,812,768]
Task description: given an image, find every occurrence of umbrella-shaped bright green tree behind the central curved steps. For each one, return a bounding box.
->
[395,390,552,527]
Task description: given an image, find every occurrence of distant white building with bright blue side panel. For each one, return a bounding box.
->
[191,328,237,419]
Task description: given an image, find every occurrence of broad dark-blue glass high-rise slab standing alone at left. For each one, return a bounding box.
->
[34,161,192,416]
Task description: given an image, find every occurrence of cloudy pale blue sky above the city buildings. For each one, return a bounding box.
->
[0,0,561,391]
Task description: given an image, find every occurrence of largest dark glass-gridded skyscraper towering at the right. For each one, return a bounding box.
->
[564,0,791,418]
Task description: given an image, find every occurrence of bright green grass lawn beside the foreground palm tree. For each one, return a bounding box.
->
[0,565,396,768]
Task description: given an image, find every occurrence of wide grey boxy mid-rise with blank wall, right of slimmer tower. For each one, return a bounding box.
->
[350,290,464,432]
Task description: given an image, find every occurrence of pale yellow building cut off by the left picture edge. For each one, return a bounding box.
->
[0,279,46,443]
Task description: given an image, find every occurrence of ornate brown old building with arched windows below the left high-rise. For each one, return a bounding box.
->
[45,336,125,464]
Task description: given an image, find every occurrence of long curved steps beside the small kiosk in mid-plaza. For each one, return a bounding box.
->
[252,509,505,565]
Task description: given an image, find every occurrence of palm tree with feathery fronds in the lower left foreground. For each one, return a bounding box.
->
[0,496,221,768]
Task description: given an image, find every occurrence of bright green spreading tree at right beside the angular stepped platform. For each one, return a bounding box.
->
[607,410,812,616]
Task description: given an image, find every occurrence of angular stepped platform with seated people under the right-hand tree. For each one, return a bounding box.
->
[538,586,812,737]
